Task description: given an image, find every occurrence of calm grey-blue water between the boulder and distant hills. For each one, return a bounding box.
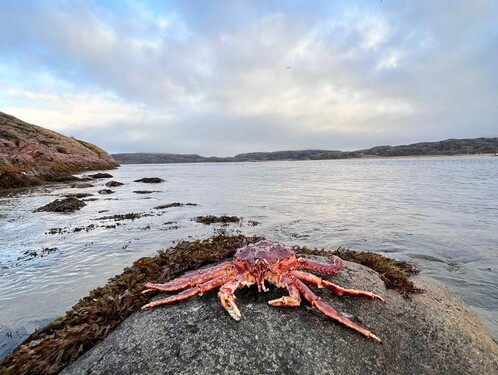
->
[0,157,498,357]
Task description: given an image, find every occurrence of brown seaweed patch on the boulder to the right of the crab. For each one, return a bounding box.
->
[294,246,425,299]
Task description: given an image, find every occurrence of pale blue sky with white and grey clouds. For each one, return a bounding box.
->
[0,0,498,156]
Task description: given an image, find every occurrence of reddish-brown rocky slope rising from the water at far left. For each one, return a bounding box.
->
[0,112,119,189]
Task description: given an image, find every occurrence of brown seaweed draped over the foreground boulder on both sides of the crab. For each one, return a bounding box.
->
[0,235,421,375]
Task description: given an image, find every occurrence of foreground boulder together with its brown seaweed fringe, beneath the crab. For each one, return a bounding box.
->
[0,235,498,374]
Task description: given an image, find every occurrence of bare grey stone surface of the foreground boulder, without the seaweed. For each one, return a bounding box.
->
[62,259,498,375]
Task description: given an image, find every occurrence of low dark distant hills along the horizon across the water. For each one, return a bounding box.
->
[112,138,498,164]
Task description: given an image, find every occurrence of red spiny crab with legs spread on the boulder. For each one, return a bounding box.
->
[142,241,384,342]
